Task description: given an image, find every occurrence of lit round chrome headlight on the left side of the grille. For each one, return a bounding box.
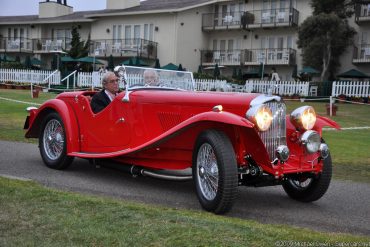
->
[246,104,272,131]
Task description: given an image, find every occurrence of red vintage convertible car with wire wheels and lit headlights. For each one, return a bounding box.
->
[25,66,340,214]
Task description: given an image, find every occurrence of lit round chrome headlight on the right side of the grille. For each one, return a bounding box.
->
[290,106,316,130]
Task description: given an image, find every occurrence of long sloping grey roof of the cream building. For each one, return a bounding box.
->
[0,0,216,25]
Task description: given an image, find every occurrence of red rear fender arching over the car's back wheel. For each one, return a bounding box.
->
[25,99,80,153]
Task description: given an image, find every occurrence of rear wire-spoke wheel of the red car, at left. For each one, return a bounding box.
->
[39,112,73,170]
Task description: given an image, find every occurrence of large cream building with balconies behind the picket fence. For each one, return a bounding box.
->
[0,0,370,80]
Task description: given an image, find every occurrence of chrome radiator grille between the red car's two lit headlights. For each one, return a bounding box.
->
[259,101,286,161]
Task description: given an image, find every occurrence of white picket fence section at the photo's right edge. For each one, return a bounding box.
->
[331,81,370,97]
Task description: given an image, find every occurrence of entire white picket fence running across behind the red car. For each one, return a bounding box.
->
[0,69,318,96]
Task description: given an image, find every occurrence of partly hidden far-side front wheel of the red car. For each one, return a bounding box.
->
[283,154,332,202]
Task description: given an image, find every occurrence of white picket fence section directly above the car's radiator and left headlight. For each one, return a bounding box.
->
[244,80,310,96]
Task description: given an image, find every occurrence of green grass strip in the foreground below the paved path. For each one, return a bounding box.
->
[0,177,370,246]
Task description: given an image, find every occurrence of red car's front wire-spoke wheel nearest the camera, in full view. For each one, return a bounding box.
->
[193,130,238,214]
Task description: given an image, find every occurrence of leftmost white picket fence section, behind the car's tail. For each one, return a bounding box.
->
[0,69,60,85]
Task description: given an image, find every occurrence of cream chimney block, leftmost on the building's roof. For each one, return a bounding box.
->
[39,0,73,18]
